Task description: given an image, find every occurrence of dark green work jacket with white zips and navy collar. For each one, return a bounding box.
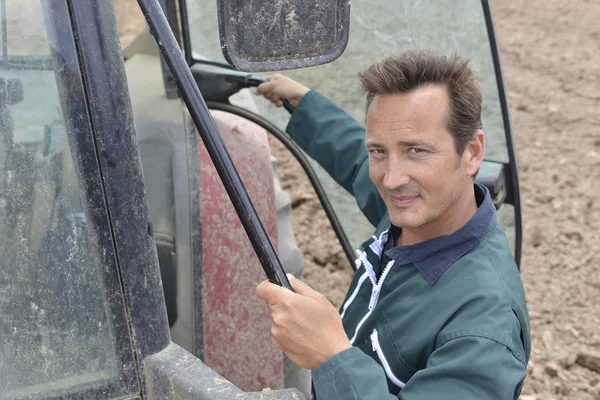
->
[287,90,531,400]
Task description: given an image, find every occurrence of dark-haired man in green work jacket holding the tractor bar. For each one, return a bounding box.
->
[257,52,531,400]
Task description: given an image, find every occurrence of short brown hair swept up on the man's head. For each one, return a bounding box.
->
[358,51,481,154]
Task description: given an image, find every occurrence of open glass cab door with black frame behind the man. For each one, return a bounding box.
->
[184,0,521,265]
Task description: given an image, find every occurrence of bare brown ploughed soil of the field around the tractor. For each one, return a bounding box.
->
[115,0,600,400]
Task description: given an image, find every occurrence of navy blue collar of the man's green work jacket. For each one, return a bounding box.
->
[383,183,496,285]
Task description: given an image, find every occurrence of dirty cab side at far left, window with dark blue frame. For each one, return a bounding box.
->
[0,0,298,400]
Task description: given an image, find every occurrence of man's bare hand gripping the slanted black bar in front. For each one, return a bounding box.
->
[256,274,352,370]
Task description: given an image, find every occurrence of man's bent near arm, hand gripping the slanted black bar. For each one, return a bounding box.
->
[257,275,526,400]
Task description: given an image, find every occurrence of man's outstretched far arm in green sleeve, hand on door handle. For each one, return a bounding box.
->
[257,75,386,226]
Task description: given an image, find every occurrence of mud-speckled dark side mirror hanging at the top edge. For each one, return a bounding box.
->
[217,0,350,72]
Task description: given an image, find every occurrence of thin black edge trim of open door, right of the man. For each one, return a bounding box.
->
[481,0,523,269]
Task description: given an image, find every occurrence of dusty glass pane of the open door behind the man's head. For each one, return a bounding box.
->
[186,0,514,250]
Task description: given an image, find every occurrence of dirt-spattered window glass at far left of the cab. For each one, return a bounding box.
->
[0,0,137,399]
